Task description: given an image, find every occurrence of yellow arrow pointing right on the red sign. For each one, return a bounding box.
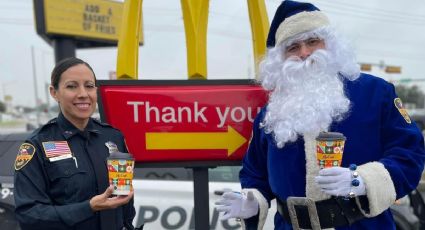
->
[146,125,246,156]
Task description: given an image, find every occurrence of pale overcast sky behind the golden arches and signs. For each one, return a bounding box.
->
[0,0,425,106]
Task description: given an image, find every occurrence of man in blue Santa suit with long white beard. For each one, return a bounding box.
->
[217,1,425,230]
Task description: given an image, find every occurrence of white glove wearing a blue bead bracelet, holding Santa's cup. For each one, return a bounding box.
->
[315,167,366,196]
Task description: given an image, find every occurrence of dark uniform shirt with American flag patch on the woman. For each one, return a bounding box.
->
[14,113,135,230]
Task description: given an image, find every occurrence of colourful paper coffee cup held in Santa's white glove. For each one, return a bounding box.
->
[316,132,346,169]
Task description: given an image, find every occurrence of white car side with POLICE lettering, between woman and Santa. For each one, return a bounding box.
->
[134,166,276,229]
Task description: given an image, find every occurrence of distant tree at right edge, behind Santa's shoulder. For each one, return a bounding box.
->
[395,85,425,108]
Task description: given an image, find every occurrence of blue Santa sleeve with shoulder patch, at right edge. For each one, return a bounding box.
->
[380,84,425,199]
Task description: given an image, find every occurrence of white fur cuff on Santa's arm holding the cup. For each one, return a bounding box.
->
[357,162,396,217]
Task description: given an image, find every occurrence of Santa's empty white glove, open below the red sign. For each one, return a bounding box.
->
[215,191,258,220]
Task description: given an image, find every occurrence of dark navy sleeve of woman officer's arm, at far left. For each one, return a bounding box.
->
[14,140,94,229]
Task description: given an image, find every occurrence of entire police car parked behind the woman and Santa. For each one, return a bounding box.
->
[0,133,425,230]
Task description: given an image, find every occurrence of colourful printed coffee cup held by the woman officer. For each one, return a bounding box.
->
[107,152,134,195]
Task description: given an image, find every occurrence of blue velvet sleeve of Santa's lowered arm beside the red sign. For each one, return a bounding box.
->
[239,108,274,202]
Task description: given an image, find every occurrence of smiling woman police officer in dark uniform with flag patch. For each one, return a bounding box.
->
[15,58,135,230]
